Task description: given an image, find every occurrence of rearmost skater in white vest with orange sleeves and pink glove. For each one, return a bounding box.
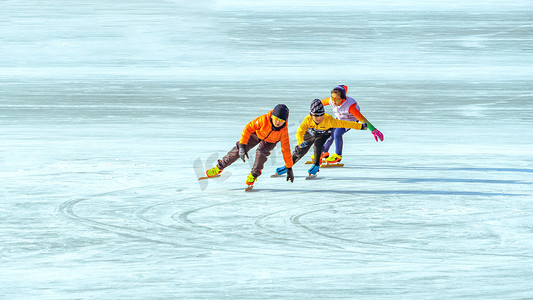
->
[316,85,383,164]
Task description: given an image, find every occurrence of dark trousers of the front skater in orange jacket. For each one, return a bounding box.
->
[217,133,277,178]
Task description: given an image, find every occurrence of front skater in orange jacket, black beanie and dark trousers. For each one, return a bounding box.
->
[206,104,294,186]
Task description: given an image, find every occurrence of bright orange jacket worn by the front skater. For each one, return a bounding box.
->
[239,110,293,168]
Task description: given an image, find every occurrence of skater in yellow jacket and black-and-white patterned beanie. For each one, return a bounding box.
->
[276,99,367,175]
